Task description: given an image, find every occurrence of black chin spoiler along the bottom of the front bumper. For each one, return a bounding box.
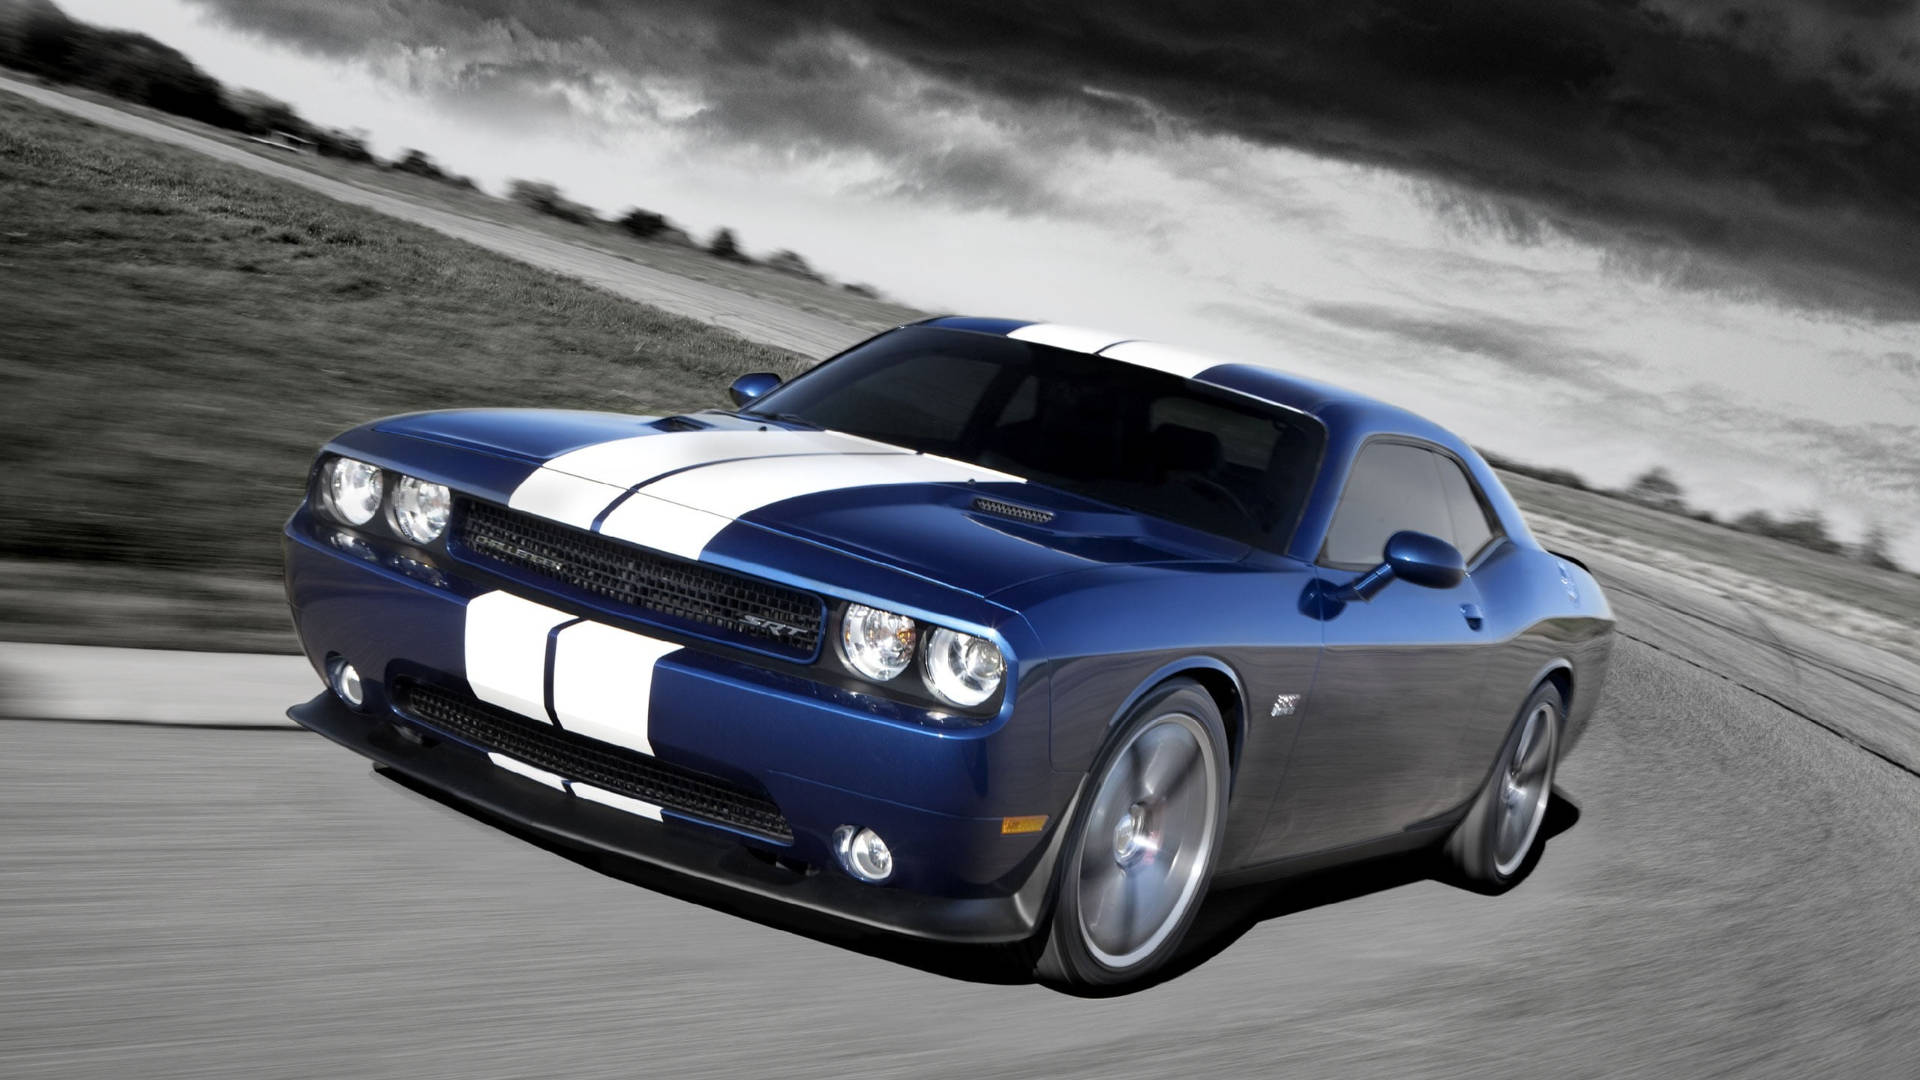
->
[286,692,1062,944]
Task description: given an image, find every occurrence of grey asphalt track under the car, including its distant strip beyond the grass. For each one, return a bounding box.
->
[0,75,1920,1080]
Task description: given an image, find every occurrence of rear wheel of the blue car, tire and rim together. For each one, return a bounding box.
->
[1442,682,1567,894]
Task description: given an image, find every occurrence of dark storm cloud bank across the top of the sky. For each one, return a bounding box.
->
[191,0,1920,317]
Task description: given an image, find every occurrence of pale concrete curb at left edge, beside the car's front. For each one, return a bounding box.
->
[0,642,307,728]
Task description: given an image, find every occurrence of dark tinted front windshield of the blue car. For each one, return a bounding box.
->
[747,327,1325,550]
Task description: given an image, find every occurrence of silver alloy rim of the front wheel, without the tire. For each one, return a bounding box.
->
[1077,713,1221,969]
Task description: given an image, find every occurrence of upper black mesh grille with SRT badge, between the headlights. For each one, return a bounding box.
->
[466,500,824,645]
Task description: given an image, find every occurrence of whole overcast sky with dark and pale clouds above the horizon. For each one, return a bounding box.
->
[61,0,1920,553]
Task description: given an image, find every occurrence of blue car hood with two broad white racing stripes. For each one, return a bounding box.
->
[376,409,1246,596]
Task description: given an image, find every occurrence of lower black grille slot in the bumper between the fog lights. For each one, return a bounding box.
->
[397,682,793,844]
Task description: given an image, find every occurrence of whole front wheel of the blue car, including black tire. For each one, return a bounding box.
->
[1035,678,1231,988]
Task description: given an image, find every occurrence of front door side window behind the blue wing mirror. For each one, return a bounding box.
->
[1321,442,1451,567]
